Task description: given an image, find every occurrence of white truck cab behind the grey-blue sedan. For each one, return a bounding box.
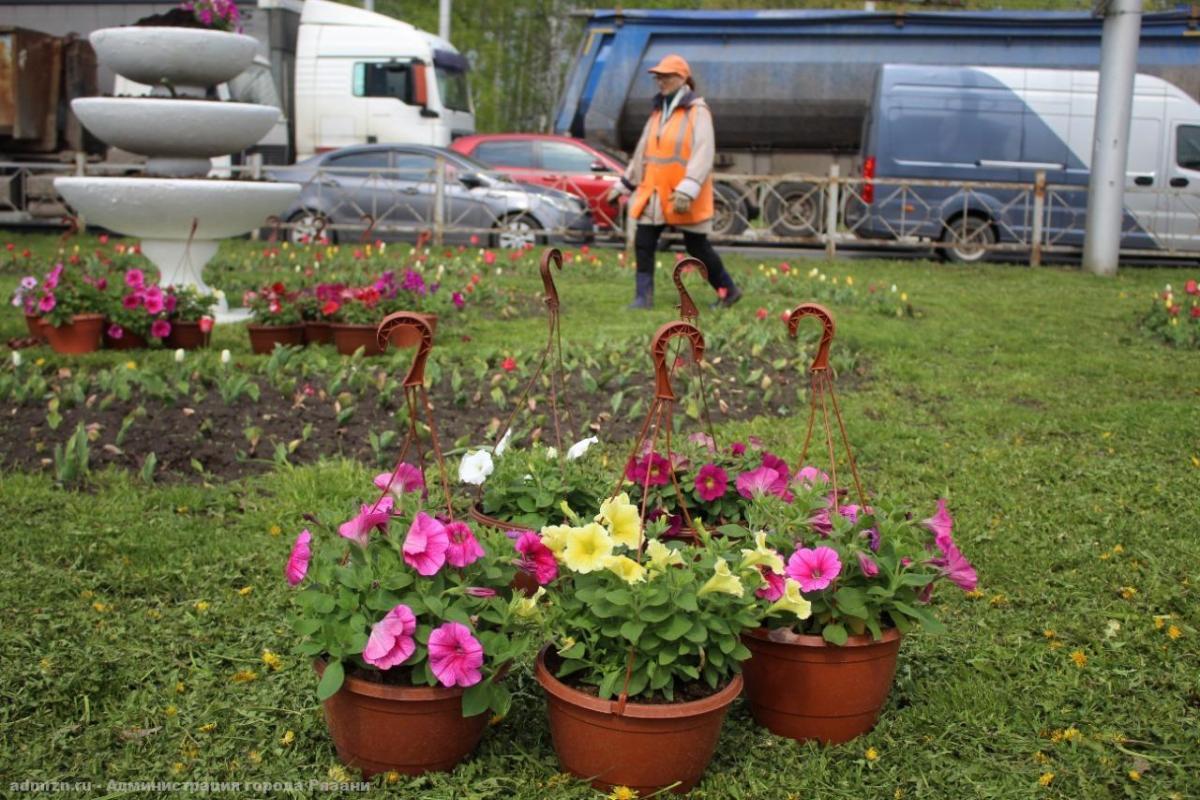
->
[295,0,475,161]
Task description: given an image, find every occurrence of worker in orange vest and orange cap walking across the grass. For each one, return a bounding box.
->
[608,55,742,308]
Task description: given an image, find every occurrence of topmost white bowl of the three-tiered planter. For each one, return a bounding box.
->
[88,25,258,89]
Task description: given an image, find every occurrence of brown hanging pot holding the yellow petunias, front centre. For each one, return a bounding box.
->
[536,649,742,796]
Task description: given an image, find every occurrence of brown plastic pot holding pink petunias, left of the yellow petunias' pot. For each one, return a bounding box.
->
[313,661,487,777]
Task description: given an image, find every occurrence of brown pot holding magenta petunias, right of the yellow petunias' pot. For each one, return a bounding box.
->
[742,628,900,744]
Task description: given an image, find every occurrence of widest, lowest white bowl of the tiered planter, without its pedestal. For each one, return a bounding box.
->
[54,178,300,240]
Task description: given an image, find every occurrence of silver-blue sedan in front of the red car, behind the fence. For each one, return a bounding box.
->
[266,144,593,247]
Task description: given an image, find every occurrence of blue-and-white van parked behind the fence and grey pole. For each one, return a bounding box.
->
[847,65,1200,260]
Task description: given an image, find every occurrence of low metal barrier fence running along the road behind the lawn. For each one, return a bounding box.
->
[0,158,1200,265]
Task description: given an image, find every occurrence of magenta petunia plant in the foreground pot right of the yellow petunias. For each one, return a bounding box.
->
[721,467,978,644]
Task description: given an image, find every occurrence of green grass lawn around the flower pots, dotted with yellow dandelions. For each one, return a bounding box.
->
[0,236,1200,800]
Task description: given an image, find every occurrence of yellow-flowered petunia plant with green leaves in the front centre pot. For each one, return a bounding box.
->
[515,493,809,702]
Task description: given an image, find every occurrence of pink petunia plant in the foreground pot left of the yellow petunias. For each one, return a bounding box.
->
[284,464,533,716]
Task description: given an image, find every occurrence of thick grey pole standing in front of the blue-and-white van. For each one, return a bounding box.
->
[1084,0,1141,276]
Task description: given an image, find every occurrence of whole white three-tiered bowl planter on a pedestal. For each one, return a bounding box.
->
[54,26,300,321]
